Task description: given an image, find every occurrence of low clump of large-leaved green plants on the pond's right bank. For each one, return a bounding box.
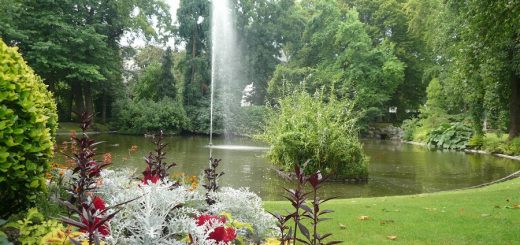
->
[426,123,473,150]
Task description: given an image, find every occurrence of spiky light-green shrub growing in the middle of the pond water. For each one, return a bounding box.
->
[258,92,368,179]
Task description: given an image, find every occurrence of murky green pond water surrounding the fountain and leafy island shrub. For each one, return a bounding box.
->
[55,134,520,200]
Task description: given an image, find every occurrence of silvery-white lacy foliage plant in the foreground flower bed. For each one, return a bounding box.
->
[99,169,274,245]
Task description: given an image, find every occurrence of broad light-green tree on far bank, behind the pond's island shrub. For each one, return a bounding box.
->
[269,1,405,124]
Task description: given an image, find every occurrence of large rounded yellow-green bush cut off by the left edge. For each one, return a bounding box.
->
[0,39,58,217]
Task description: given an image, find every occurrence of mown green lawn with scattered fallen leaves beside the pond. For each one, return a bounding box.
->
[265,178,520,244]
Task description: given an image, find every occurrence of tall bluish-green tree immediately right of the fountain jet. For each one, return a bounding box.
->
[234,0,304,104]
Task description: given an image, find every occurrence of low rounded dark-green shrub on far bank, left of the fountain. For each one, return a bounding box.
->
[114,97,188,134]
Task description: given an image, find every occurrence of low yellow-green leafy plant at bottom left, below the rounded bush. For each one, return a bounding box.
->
[18,208,64,245]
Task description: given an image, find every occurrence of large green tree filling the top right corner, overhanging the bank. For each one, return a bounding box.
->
[405,0,520,138]
